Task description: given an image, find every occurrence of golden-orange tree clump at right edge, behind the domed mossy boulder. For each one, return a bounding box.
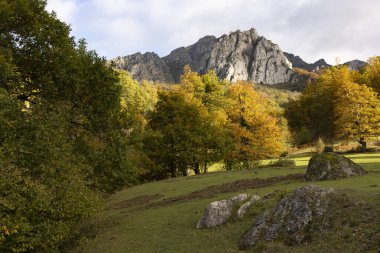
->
[286,66,379,148]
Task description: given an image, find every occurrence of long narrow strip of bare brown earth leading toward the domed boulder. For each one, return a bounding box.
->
[136,173,305,211]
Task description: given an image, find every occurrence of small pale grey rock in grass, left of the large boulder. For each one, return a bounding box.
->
[197,194,249,228]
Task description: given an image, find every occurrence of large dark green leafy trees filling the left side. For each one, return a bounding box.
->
[0,0,136,249]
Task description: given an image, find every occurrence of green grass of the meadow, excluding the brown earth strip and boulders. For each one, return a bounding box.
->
[70,153,380,253]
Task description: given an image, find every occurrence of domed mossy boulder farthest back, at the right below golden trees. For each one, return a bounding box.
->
[306,153,366,181]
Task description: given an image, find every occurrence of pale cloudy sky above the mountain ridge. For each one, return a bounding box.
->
[47,0,380,64]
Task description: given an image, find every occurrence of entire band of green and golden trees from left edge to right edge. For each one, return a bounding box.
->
[0,0,380,252]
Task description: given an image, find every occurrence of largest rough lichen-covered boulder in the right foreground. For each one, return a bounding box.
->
[239,185,340,248]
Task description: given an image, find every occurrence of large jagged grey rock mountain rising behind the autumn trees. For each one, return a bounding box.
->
[113,29,296,84]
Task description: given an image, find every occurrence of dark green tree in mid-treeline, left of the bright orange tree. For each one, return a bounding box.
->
[144,91,205,179]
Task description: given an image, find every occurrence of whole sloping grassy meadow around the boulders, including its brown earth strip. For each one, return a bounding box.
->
[69,153,380,253]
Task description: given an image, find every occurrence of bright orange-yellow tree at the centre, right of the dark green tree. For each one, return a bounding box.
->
[227,82,284,167]
